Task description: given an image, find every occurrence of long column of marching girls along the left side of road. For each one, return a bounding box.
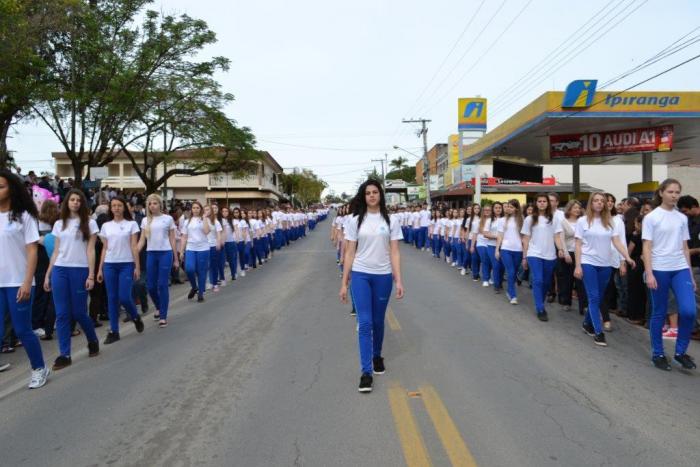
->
[0,166,328,389]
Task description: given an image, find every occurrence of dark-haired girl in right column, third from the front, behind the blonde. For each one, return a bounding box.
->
[520,193,564,321]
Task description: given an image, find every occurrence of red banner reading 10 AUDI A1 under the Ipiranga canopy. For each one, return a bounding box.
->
[549,125,673,159]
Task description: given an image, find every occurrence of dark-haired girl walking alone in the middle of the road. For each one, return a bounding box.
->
[340,180,404,392]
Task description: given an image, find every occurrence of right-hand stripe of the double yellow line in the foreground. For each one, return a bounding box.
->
[420,385,476,467]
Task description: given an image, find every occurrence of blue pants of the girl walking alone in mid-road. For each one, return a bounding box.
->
[350,271,393,373]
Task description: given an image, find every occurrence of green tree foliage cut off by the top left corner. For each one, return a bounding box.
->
[0,0,78,168]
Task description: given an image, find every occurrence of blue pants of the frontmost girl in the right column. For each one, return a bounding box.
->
[649,269,696,356]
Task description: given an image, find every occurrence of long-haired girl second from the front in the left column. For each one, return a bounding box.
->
[43,189,100,370]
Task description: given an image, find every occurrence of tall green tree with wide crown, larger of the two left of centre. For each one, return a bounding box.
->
[34,0,242,184]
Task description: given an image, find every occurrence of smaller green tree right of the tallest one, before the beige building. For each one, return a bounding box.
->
[119,38,259,193]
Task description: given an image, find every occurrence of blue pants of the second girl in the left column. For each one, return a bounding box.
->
[51,266,97,357]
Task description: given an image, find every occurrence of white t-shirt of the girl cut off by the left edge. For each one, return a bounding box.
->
[0,212,39,288]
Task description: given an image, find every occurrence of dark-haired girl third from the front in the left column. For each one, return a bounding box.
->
[97,196,144,345]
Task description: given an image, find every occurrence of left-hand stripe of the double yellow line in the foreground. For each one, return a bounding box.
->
[389,383,432,467]
